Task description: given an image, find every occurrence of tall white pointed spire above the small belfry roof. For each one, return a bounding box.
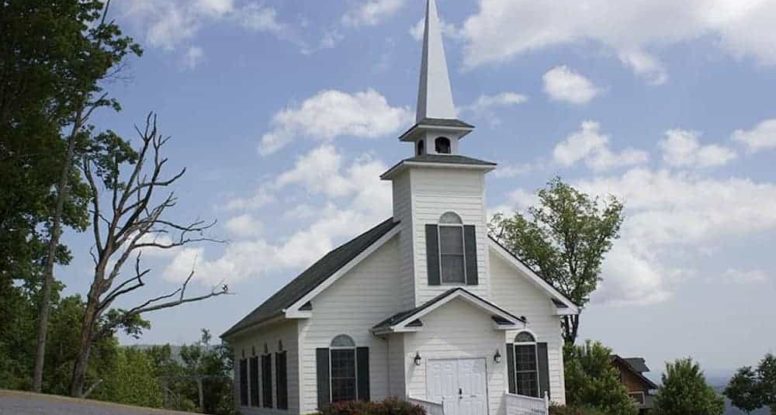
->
[415,0,456,122]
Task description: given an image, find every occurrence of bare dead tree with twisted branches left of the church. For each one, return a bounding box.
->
[70,113,228,397]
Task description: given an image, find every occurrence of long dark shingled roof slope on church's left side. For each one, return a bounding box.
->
[221,218,398,338]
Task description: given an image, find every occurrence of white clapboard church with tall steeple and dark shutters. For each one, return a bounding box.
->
[221,0,579,415]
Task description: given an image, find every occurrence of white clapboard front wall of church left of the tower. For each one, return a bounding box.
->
[300,237,401,413]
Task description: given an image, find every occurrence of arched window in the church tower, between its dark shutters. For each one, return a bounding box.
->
[439,212,466,284]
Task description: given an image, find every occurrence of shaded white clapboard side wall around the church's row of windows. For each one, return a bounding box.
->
[231,320,299,415]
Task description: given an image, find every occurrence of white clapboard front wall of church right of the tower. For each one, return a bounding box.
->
[490,253,566,404]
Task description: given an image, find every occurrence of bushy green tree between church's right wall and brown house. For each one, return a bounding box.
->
[564,340,638,415]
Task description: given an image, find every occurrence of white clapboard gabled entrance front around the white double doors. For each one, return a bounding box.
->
[404,298,506,415]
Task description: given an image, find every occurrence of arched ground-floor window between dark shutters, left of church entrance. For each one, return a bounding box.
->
[329,334,357,402]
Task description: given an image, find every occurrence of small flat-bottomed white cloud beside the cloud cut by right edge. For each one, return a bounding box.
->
[658,129,736,167]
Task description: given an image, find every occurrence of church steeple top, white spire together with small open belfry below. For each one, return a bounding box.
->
[399,0,474,156]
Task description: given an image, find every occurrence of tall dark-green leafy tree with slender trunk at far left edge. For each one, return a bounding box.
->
[0,0,140,391]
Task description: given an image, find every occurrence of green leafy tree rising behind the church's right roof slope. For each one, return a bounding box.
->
[490,178,623,344]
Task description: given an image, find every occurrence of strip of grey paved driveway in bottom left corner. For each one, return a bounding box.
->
[0,390,194,415]
